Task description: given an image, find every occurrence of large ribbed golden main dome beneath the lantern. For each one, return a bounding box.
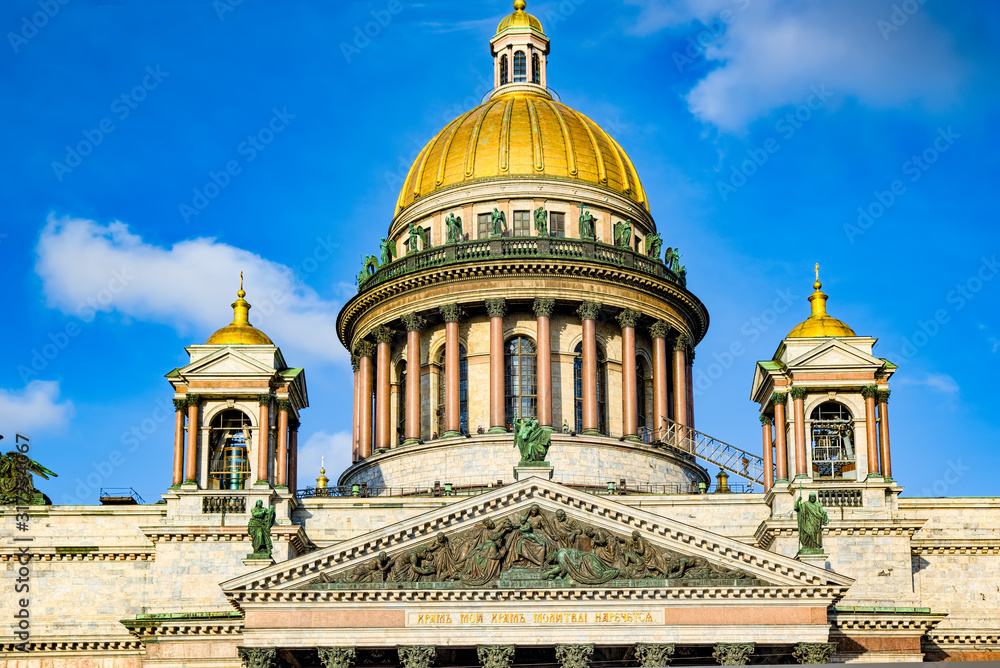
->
[396,92,649,213]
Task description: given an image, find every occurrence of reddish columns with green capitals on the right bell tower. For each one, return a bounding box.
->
[760,385,892,492]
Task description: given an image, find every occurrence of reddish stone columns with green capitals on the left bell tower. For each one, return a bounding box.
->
[172,394,299,494]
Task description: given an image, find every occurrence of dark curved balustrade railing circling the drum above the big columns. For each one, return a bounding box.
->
[358,237,686,292]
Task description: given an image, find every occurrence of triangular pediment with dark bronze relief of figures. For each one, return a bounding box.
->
[222,477,853,598]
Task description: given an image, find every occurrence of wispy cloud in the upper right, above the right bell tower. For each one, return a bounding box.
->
[627,0,963,132]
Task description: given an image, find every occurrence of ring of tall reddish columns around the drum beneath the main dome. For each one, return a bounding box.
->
[351,297,694,461]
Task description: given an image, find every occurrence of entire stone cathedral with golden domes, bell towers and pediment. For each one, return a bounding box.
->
[0,0,1000,668]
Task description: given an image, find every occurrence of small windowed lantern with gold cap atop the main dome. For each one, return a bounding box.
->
[490,0,551,97]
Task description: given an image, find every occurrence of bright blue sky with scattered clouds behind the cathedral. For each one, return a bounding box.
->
[0,0,1000,503]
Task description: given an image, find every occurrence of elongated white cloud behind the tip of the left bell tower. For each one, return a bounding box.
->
[35,218,347,364]
